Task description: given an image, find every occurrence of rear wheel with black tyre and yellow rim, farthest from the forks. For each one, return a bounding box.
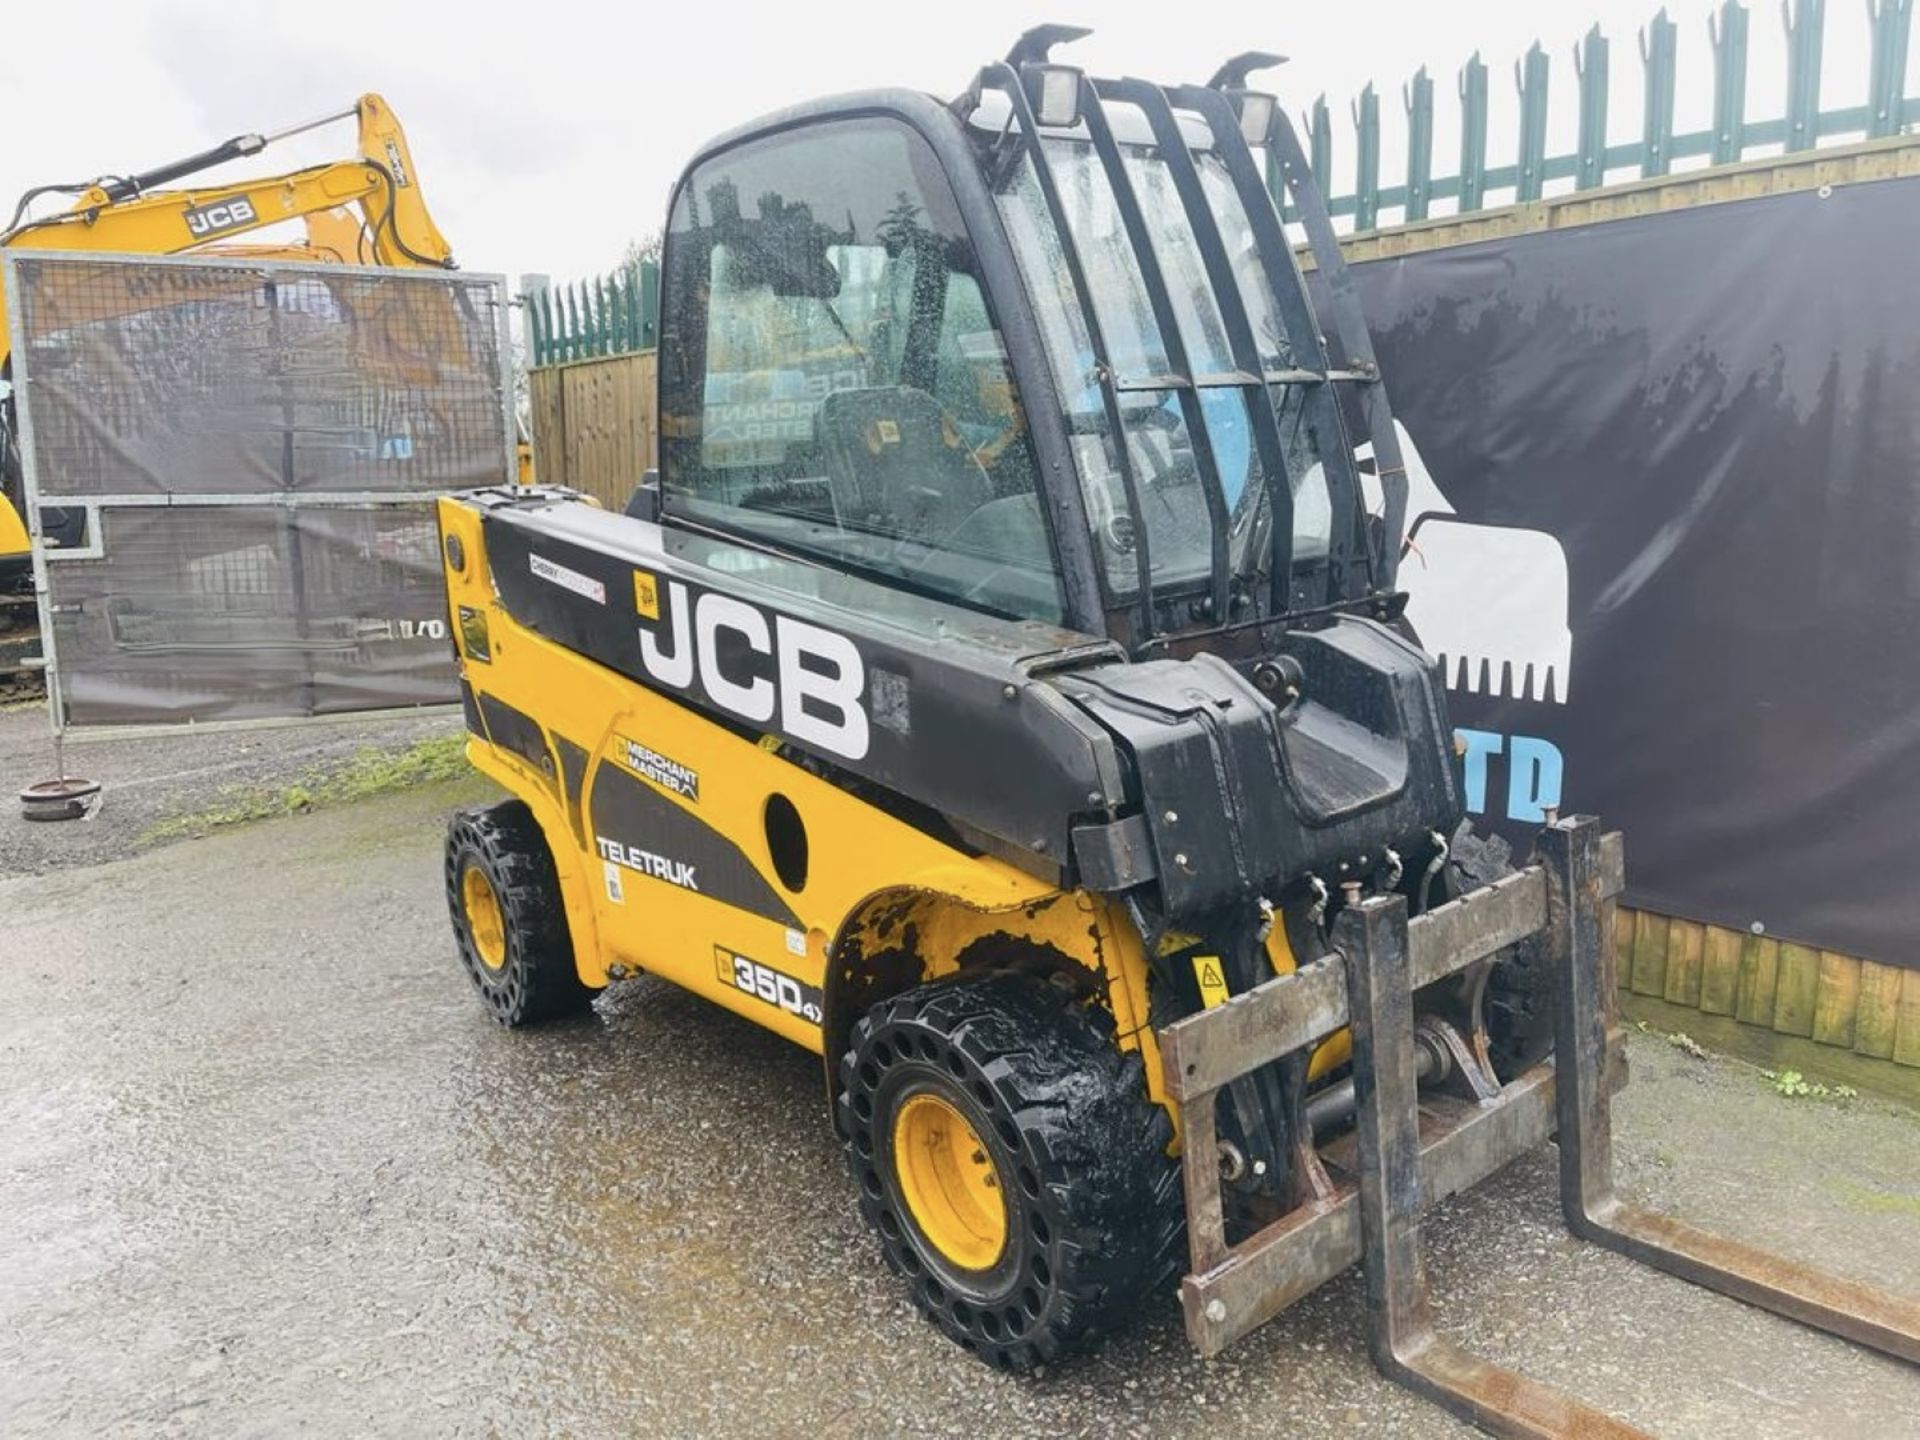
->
[445,801,593,1027]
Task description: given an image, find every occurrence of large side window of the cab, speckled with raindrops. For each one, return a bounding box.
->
[660,117,1062,622]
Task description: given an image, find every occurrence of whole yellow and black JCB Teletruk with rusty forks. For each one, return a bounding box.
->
[440,27,1920,1436]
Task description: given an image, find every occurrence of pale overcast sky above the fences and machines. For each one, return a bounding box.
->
[0,0,1920,288]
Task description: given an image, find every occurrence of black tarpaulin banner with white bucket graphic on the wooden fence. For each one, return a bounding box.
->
[1356,180,1920,966]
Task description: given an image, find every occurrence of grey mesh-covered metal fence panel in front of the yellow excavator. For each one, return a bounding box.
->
[12,255,513,726]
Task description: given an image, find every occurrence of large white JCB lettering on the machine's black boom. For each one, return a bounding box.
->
[636,580,872,760]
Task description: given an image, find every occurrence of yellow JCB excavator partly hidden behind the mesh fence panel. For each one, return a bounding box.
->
[0,94,453,622]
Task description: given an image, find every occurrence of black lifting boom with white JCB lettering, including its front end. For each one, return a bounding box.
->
[474,492,1461,920]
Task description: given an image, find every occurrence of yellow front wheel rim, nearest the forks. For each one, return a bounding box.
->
[893,1091,1006,1269]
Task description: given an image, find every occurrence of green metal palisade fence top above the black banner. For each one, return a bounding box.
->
[1275,0,1920,230]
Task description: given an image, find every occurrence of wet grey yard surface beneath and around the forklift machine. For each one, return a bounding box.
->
[0,783,1920,1440]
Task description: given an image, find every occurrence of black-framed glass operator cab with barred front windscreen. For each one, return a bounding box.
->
[659,27,1398,653]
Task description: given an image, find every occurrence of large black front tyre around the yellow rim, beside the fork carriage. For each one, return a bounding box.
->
[839,972,1187,1371]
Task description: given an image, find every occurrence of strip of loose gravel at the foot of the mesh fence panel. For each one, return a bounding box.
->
[0,701,461,876]
